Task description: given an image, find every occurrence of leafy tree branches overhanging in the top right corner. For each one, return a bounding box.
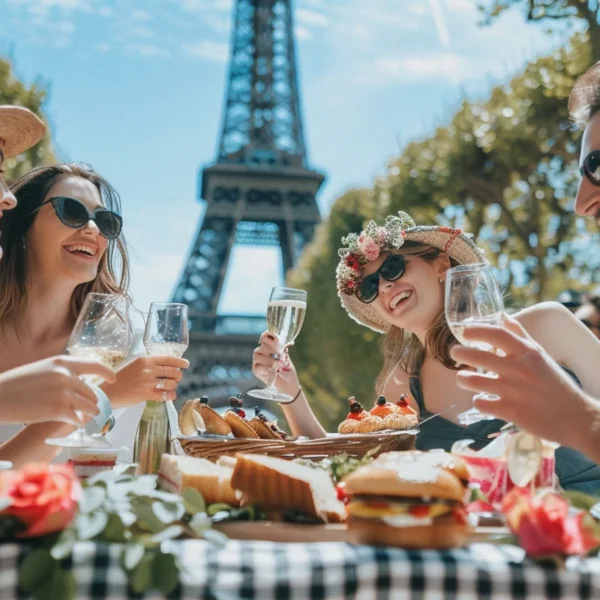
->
[479,0,600,62]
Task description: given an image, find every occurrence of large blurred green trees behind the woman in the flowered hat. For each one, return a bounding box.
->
[288,35,600,431]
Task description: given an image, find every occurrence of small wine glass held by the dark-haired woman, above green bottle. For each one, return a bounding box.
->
[144,302,190,401]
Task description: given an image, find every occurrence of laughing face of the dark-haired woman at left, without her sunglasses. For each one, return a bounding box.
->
[25,175,108,285]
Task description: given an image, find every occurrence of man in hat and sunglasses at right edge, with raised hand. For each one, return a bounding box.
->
[451,62,600,463]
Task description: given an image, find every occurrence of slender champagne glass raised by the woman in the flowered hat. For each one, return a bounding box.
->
[249,287,306,404]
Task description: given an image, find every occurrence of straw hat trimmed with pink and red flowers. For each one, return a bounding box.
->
[336,212,486,333]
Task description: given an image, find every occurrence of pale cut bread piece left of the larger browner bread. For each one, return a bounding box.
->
[158,454,240,506]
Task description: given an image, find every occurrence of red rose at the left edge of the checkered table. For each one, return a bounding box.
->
[0,464,81,537]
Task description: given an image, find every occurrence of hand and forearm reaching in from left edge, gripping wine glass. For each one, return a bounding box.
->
[0,356,116,425]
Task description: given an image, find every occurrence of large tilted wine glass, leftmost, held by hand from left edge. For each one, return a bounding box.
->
[46,293,131,448]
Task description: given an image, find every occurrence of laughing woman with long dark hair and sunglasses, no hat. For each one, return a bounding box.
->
[0,163,189,461]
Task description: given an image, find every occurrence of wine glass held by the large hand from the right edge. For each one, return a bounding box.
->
[445,263,504,425]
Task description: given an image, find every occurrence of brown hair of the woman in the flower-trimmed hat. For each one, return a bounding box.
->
[375,241,459,394]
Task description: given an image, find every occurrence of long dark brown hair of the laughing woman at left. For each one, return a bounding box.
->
[0,164,130,329]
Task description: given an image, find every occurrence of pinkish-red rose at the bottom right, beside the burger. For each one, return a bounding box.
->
[502,488,600,556]
